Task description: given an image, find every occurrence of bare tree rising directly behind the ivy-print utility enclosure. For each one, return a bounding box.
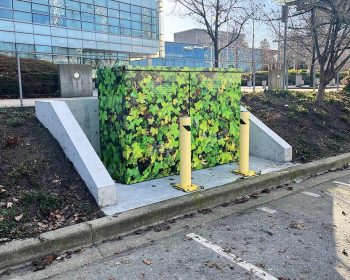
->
[174,0,251,67]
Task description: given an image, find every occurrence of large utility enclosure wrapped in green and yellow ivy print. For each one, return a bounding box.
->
[97,66,241,184]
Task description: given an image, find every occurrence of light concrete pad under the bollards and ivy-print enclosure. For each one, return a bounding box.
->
[102,157,293,215]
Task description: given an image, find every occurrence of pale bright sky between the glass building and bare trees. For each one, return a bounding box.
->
[164,0,277,47]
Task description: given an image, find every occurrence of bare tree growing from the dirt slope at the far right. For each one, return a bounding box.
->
[294,0,350,103]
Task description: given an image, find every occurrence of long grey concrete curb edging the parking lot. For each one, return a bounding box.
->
[0,153,350,270]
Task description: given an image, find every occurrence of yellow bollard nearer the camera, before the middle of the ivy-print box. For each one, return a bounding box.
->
[175,117,199,192]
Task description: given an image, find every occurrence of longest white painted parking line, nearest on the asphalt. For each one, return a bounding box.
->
[186,233,278,280]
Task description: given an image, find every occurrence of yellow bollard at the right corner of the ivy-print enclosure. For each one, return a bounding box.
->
[235,111,256,177]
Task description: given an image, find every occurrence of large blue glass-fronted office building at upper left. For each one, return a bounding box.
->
[0,0,160,63]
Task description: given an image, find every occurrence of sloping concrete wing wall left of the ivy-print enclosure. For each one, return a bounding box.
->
[35,99,117,207]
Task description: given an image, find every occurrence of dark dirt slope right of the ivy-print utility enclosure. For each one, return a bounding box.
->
[242,91,350,162]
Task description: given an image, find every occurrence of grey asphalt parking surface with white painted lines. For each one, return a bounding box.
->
[5,170,350,280]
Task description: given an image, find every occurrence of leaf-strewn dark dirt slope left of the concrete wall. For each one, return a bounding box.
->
[0,108,103,242]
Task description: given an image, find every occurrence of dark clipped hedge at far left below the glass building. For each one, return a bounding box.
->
[0,55,59,98]
